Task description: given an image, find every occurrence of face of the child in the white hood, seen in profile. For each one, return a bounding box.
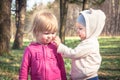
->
[76,23,86,40]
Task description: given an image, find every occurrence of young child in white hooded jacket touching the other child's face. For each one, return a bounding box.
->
[55,9,106,80]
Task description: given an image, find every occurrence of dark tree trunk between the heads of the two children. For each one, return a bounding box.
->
[59,0,68,43]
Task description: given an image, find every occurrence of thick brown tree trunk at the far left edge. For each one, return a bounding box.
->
[0,0,12,55]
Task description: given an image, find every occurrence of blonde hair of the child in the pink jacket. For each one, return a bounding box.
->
[32,12,58,36]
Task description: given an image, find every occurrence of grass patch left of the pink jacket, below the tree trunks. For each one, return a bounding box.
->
[0,50,22,80]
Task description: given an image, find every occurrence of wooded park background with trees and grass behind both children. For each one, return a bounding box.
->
[0,0,120,80]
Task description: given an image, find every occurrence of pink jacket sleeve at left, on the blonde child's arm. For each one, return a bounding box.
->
[19,47,30,80]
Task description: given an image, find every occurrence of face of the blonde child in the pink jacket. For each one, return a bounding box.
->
[37,31,56,44]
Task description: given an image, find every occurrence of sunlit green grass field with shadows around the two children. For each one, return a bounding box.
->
[0,37,120,80]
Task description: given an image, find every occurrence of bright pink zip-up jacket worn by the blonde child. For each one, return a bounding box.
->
[19,43,67,80]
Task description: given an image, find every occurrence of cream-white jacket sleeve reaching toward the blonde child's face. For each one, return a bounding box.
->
[57,41,95,59]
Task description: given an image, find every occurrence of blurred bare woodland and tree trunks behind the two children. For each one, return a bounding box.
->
[0,0,120,53]
